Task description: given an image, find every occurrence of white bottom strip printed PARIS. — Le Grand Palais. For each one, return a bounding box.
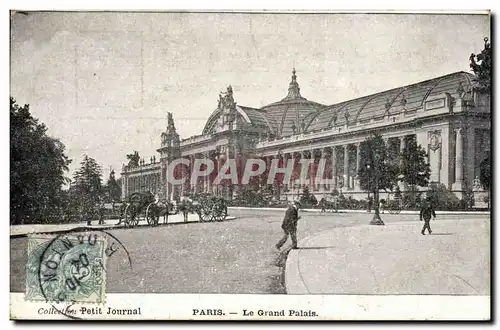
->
[10,293,490,321]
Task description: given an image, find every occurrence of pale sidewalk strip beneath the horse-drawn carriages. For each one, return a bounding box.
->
[10,214,236,237]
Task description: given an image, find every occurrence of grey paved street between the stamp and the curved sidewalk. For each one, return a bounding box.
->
[10,210,489,293]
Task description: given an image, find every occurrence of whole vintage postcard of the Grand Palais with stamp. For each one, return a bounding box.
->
[10,10,493,321]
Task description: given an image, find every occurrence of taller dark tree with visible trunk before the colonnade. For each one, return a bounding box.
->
[358,134,399,225]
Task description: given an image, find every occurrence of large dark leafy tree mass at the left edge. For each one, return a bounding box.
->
[10,97,71,224]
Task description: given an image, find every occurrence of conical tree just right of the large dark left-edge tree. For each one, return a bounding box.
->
[72,155,103,219]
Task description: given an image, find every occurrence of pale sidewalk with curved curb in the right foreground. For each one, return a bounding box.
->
[285,218,491,295]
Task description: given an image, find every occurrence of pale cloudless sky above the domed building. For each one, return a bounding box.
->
[10,12,490,177]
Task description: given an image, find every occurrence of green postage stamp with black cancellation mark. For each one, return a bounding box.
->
[25,233,106,304]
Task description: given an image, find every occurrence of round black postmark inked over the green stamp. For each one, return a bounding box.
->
[37,229,132,319]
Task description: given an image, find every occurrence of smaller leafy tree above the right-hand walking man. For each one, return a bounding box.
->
[401,139,431,204]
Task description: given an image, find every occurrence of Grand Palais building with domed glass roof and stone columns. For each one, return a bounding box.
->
[121,69,491,201]
